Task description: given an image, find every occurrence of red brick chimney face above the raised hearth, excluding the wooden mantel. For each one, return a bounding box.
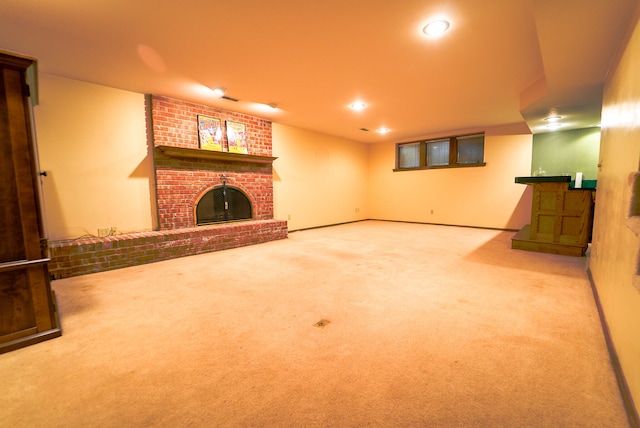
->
[151,95,273,230]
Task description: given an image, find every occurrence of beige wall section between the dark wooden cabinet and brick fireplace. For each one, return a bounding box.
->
[34,75,156,240]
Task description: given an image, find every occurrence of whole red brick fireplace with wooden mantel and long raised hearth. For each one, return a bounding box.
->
[49,95,287,278]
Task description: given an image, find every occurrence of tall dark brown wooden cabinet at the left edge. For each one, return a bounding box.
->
[0,55,60,352]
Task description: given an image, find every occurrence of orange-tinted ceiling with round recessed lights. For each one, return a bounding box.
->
[0,0,639,143]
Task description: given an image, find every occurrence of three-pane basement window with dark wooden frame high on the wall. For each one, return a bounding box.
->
[394,134,486,171]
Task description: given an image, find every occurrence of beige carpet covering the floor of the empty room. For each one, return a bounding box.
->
[0,221,628,427]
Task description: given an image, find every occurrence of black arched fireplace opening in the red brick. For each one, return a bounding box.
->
[196,185,253,226]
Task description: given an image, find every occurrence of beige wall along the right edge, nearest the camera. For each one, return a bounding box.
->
[590,5,640,414]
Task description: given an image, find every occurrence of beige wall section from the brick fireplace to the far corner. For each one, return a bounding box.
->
[273,123,369,230]
